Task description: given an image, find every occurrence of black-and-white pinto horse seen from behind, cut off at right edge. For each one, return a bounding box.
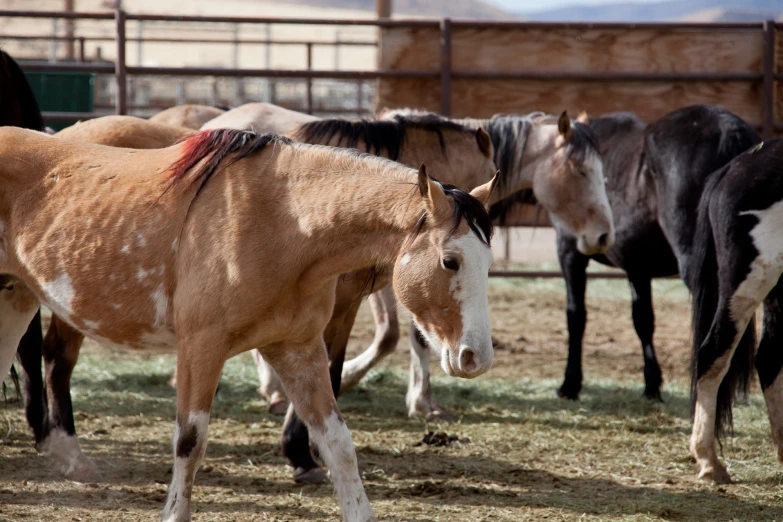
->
[687,136,783,482]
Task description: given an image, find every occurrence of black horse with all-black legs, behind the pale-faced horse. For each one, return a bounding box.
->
[557,105,760,400]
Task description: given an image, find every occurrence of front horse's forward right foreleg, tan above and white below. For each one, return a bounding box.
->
[264,339,375,522]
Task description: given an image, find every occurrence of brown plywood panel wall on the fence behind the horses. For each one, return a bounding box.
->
[378,21,783,132]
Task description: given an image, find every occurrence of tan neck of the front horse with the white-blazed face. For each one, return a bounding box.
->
[288,145,424,275]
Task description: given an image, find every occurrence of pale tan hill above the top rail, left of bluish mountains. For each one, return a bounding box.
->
[287,0,517,20]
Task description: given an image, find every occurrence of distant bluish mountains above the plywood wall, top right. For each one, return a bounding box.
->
[519,0,783,22]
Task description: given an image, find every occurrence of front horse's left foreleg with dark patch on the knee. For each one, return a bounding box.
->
[162,332,228,522]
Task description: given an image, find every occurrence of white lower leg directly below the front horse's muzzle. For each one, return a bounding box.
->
[405,324,454,422]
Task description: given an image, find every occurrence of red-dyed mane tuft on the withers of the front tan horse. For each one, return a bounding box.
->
[163,129,293,198]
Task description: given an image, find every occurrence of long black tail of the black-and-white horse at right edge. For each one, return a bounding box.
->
[686,165,756,441]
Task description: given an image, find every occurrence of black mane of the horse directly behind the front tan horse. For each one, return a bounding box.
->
[294,112,475,161]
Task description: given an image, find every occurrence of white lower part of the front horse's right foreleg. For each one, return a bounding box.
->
[308,411,375,522]
